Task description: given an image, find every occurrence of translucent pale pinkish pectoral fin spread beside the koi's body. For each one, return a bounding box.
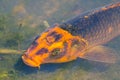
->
[79,46,118,63]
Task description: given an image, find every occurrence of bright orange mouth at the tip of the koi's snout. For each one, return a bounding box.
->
[22,54,40,67]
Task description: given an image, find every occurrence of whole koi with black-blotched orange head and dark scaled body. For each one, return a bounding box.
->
[22,2,120,67]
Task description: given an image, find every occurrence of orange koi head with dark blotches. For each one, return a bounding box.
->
[22,26,85,67]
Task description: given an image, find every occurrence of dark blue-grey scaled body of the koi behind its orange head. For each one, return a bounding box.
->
[60,2,120,45]
